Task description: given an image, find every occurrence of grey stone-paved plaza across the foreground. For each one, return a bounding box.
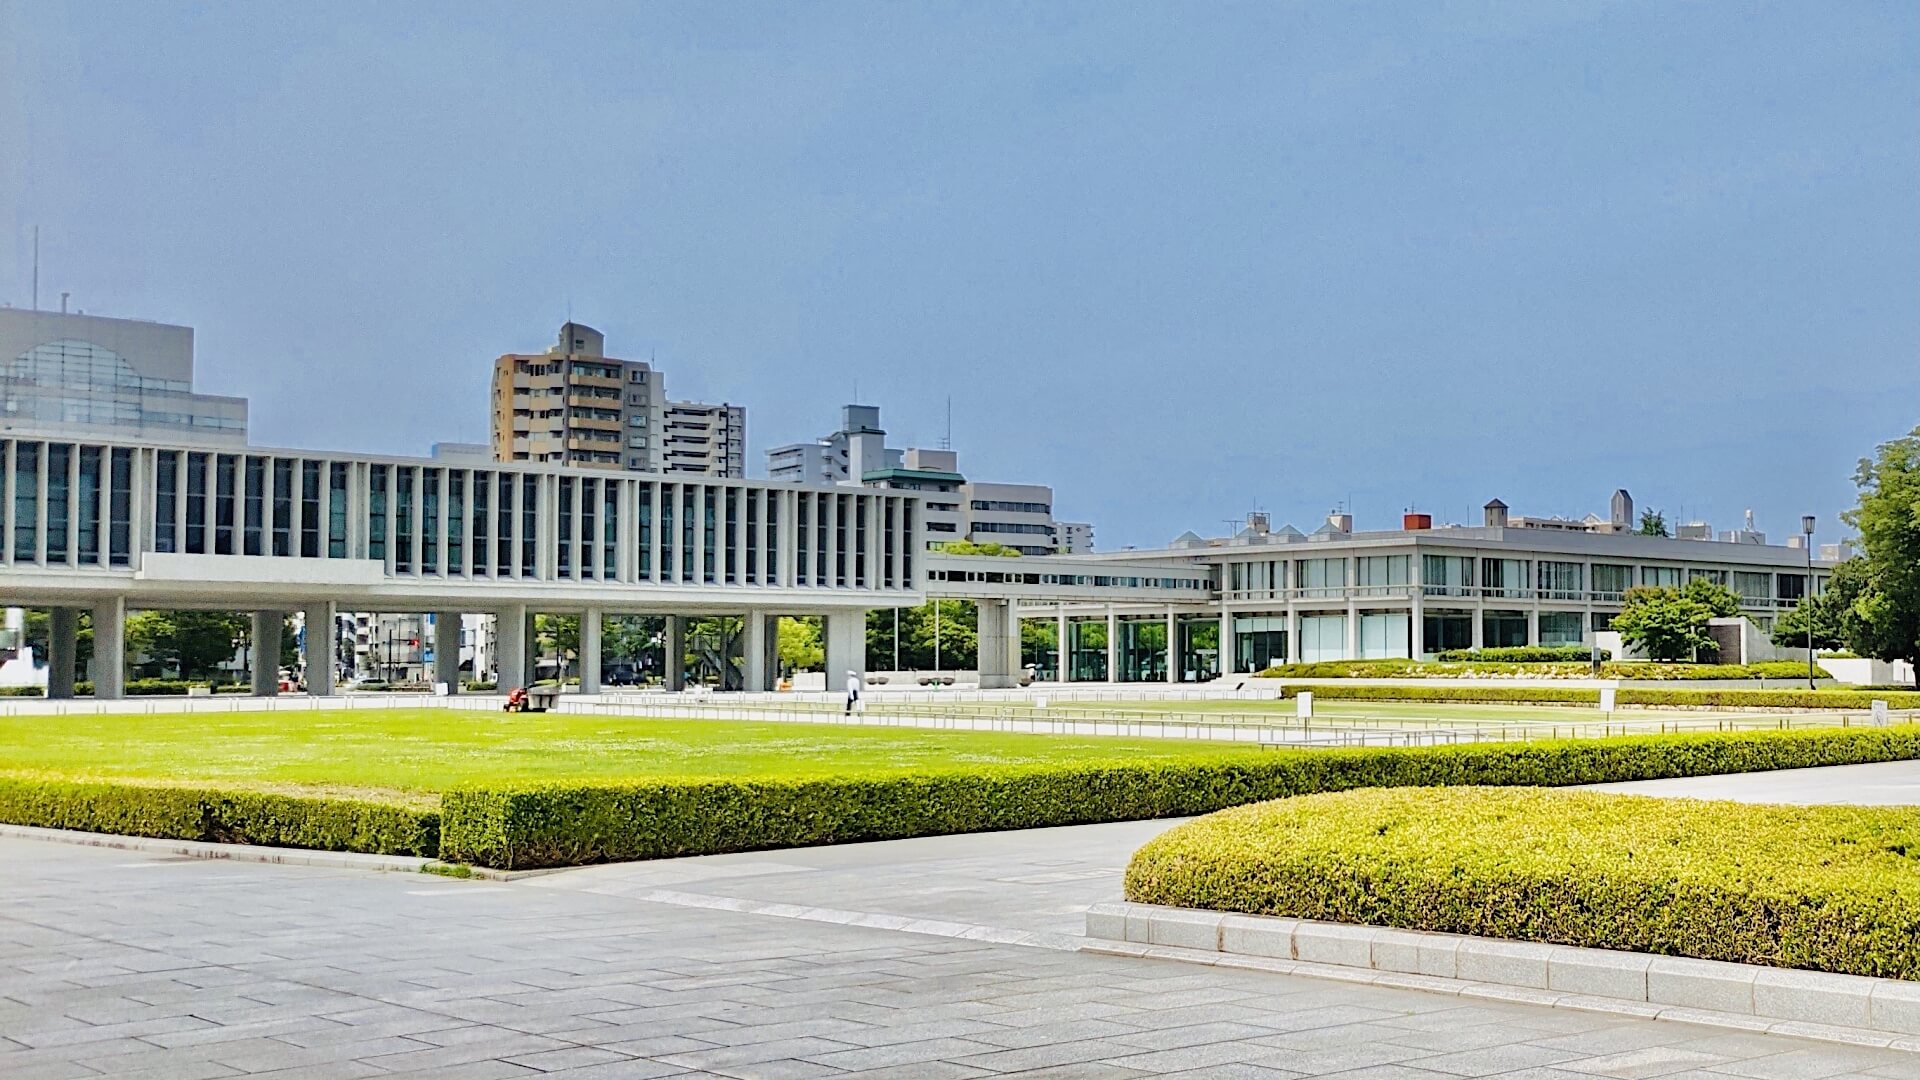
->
[0,822,1920,1080]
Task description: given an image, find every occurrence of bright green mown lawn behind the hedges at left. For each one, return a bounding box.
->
[0,709,1252,798]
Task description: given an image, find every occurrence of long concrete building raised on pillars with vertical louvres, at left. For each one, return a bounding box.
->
[0,430,925,698]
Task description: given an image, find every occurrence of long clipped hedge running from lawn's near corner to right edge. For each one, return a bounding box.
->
[440,724,1920,869]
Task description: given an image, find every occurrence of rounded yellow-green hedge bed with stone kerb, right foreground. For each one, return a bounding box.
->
[1127,788,1920,980]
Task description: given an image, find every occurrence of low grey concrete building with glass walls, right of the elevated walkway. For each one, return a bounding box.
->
[1006,515,1832,682]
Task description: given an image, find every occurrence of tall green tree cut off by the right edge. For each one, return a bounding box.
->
[1836,427,1920,680]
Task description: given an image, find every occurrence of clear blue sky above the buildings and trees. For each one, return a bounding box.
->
[0,0,1920,548]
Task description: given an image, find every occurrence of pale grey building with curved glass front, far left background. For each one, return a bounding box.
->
[0,307,246,446]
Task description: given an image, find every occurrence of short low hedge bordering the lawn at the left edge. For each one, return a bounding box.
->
[0,776,440,855]
